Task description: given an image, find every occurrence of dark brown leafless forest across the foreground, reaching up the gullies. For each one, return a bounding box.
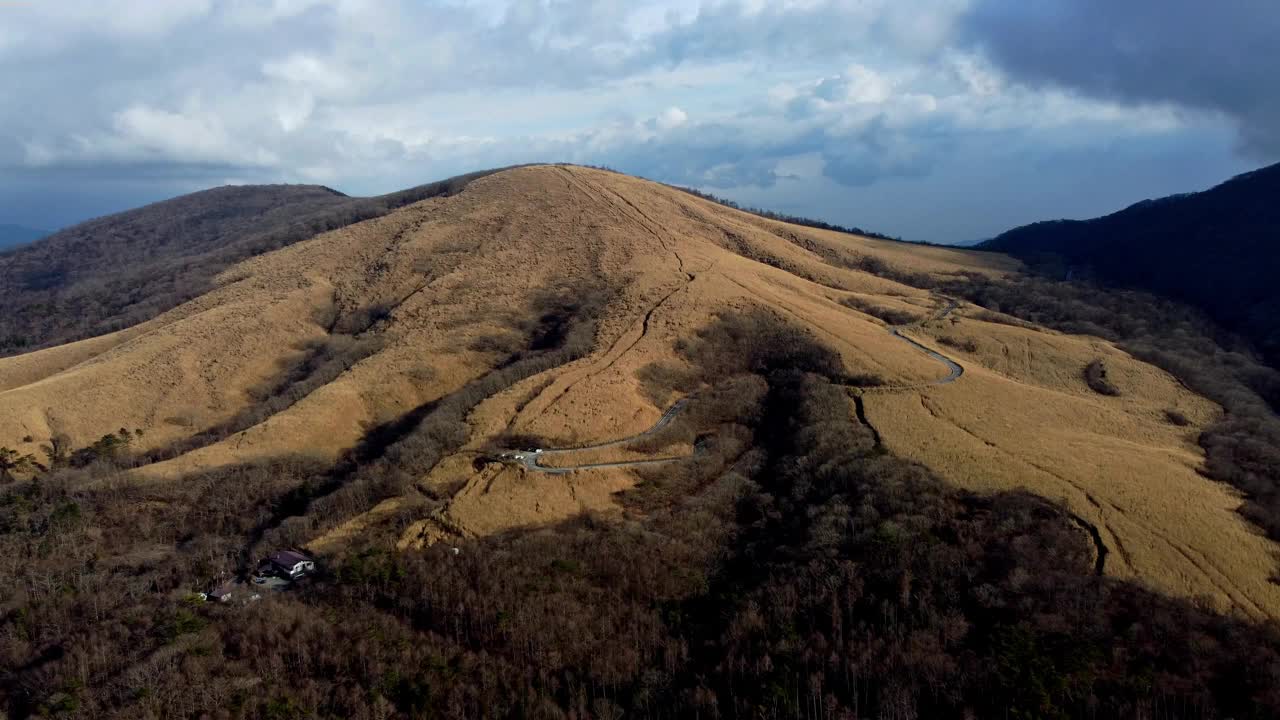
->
[0,279,1280,719]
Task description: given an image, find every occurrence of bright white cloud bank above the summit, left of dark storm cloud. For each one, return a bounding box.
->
[0,0,1259,240]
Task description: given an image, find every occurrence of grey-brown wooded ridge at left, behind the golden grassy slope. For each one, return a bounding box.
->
[0,169,509,356]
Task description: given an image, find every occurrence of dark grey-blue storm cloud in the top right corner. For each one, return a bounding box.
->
[961,0,1280,159]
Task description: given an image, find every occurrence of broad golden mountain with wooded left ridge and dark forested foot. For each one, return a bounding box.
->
[0,165,1280,717]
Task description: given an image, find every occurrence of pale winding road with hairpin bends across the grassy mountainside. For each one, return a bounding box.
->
[502,297,964,475]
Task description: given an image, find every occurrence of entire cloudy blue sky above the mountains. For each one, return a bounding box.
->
[0,0,1280,242]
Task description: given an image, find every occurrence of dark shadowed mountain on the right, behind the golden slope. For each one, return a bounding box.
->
[982,164,1280,365]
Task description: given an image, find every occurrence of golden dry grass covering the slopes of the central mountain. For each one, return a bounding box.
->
[0,167,1280,618]
